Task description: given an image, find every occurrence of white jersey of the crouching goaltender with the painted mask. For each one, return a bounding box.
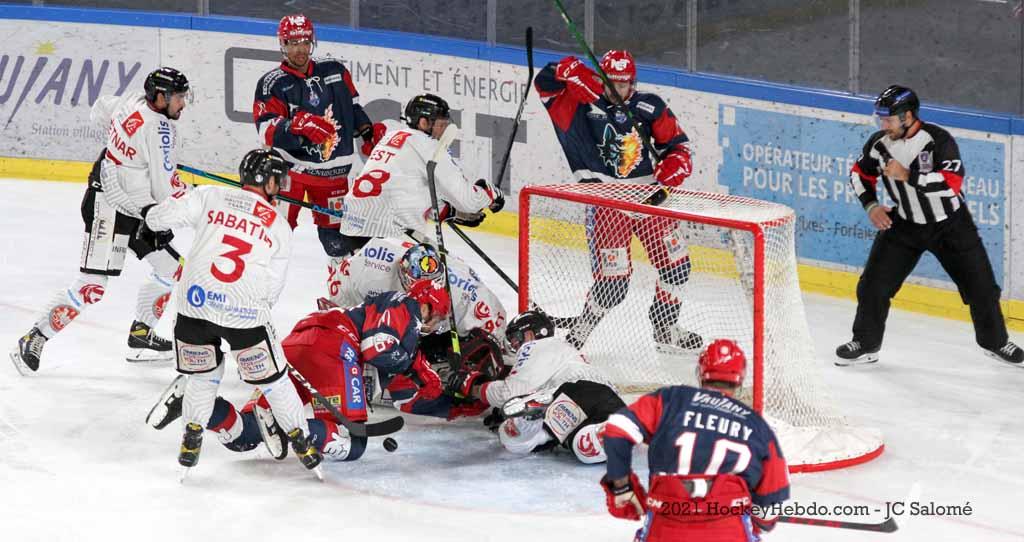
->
[329,238,507,334]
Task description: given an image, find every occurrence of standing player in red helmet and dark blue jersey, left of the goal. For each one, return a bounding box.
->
[253,14,383,265]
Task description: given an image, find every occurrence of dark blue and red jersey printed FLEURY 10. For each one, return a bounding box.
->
[604,386,790,506]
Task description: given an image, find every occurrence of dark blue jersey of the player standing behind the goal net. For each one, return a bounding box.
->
[534,62,689,182]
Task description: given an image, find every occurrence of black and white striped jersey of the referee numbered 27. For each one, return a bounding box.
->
[850,122,965,224]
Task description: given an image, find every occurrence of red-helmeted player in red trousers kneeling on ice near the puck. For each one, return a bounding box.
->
[147,280,450,461]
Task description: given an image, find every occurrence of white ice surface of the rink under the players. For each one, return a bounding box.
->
[0,180,1024,542]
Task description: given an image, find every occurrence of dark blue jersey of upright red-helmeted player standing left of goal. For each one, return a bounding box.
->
[253,58,372,177]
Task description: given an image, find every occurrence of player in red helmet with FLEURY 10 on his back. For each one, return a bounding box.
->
[601,339,790,542]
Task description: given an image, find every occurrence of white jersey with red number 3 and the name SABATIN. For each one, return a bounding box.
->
[145,186,292,329]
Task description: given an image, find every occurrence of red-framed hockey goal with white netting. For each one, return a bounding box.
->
[519,183,883,472]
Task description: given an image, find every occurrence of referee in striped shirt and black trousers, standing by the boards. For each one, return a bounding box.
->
[836,85,1024,367]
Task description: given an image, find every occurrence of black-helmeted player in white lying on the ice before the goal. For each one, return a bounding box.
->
[447,309,626,463]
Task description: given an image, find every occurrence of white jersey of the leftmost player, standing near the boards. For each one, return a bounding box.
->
[90,94,188,217]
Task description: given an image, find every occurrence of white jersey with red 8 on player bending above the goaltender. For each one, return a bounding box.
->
[341,120,493,238]
